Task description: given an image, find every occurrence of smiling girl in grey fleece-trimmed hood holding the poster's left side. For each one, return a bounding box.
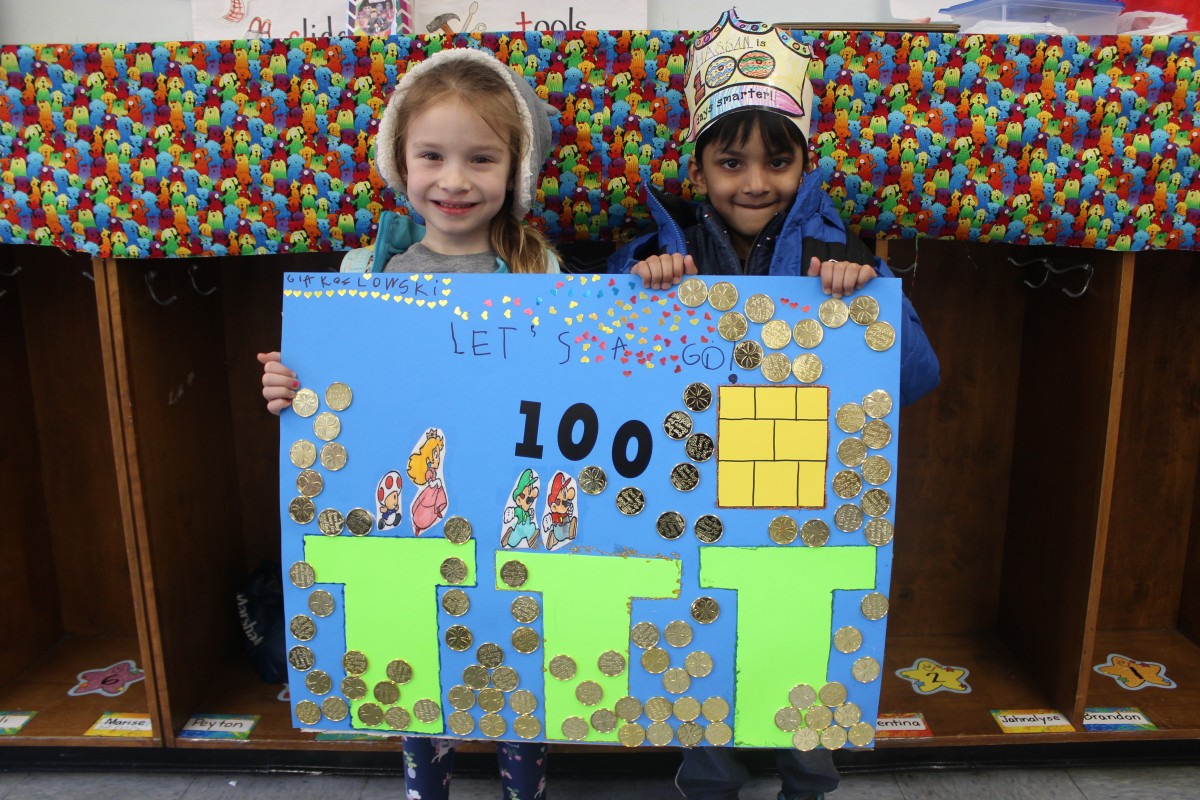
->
[258,49,560,800]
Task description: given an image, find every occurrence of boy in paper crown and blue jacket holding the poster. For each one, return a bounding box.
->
[610,11,938,800]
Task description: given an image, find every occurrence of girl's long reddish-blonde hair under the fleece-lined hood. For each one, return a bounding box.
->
[391,61,553,272]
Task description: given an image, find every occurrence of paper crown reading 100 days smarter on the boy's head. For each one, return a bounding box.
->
[684,8,812,142]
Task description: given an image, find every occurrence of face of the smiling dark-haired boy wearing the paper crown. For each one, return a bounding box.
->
[691,130,804,259]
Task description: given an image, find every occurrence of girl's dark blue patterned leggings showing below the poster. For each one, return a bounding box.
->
[403,736,546,800]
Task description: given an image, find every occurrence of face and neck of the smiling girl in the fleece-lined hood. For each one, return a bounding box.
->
[403,100,512,255]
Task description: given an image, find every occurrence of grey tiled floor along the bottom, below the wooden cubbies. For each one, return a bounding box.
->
[0,765,1200,800]
